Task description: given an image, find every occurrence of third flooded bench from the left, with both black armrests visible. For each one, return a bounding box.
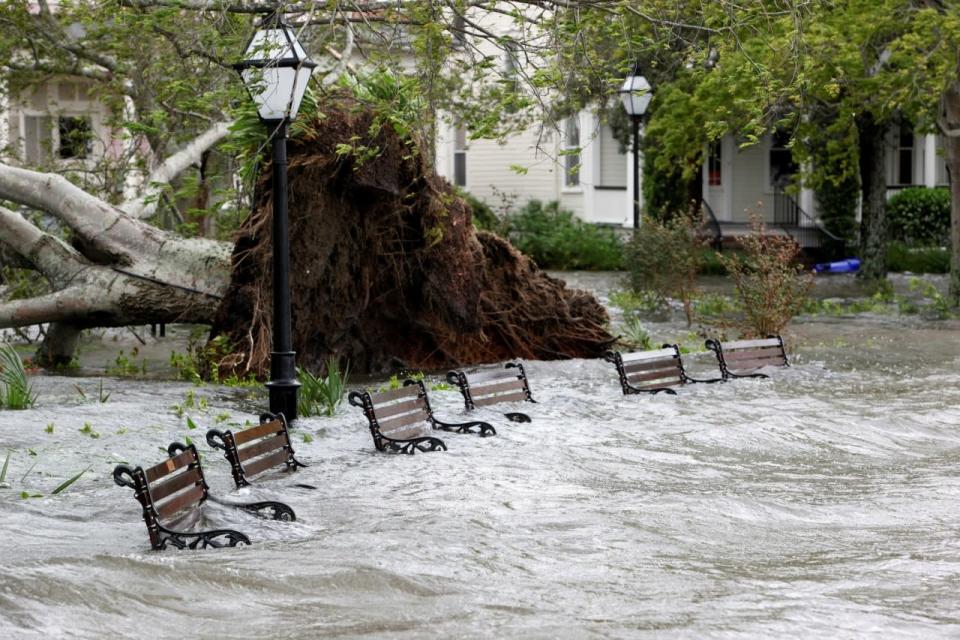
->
[347,380,497,454]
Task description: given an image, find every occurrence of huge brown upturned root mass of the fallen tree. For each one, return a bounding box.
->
[212,96,613,374]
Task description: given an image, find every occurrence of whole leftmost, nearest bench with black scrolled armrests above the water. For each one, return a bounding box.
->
[113,442,297,551]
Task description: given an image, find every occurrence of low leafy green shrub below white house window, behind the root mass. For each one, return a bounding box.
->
[504,200,623,271]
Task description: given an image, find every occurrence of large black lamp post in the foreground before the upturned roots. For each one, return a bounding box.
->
[234,13,317,421]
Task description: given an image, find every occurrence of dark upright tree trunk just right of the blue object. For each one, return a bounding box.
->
[857,112,889,281]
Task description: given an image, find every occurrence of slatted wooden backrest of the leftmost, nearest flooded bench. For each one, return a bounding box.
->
[113,442,209,547]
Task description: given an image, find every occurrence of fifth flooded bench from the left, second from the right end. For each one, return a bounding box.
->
[603,344,723,395]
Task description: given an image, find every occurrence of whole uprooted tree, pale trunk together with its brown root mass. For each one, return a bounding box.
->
[0,96,613,373]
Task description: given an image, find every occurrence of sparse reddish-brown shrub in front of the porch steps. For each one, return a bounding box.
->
[721,218,813,337]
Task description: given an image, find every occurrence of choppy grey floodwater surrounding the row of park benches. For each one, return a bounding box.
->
[0,272,960,639]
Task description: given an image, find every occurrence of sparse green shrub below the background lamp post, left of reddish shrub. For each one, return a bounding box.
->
[624,214,704,326]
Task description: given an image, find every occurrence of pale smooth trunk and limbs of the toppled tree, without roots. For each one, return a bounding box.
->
[0,165,230,332]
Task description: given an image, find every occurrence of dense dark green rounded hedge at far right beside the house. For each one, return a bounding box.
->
[887,187,950,247]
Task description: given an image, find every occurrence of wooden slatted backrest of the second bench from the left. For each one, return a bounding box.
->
[207,413,298,487]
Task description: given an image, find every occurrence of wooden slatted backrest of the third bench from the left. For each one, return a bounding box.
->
[348,380,433,451]
